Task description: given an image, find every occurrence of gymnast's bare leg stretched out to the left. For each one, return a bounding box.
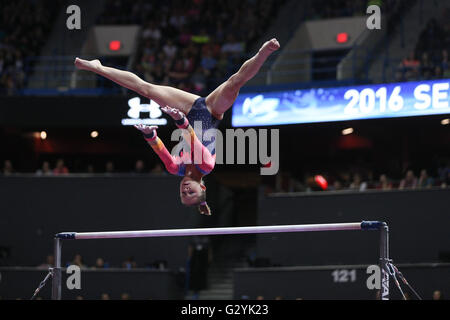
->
[75,58,199,114]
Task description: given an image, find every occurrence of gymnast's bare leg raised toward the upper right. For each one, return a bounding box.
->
[206,39,280,119]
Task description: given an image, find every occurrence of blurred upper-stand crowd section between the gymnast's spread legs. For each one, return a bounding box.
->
[98,0,283,95]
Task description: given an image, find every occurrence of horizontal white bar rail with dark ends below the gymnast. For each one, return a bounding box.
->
[55,221,386,240]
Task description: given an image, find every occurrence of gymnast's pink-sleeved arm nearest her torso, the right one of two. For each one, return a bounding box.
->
[161,107,216,174]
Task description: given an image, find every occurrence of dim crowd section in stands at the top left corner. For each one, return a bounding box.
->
[0,0,61,95]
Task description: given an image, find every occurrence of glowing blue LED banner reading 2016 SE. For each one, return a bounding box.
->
[232,79,450,127]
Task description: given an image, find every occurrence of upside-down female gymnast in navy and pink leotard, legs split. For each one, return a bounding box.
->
[75,39,280,215]
